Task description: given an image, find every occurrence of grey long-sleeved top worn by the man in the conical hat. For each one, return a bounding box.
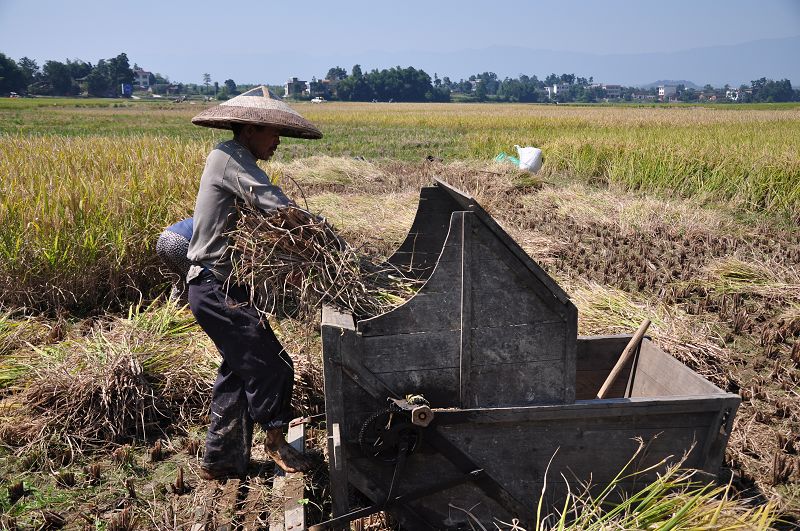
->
[187,140,290,281]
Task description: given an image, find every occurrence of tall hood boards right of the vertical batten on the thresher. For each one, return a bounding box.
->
[465,220,577,407]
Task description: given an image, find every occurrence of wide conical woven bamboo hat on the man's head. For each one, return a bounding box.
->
[192,85,322,138]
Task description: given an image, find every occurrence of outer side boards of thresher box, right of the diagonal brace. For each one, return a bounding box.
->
[438,413,714,508]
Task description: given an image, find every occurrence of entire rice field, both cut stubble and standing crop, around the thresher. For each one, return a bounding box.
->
[0,99,800,530]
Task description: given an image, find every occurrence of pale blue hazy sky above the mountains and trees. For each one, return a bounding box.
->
[0,0,800,83]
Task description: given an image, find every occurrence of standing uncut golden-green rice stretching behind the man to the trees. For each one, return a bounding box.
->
[0,98,800,312]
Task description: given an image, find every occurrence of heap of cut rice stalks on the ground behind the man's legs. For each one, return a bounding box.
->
[0,305,215,451]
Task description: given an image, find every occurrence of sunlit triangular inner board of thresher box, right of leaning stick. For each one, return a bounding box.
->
[632,339,723,397]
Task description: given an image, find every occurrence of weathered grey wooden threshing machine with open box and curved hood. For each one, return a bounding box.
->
[321,180,739,530]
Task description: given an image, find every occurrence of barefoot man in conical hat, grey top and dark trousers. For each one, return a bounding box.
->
[187,86,322,480]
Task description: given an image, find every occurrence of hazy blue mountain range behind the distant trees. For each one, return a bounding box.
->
[147,35,800,87]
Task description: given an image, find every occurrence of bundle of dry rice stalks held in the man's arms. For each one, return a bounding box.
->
[230,206,419,320]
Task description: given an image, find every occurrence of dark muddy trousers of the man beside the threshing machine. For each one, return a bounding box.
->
[189,271,294,474]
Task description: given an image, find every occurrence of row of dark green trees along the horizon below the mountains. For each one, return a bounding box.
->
[0,53,800,103]
